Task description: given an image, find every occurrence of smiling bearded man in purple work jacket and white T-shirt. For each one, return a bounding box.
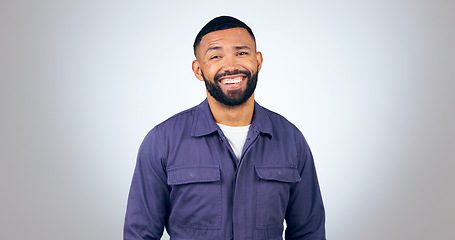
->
[124,16,325,240]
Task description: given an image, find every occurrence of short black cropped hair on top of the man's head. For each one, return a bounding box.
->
[193,16,256,55]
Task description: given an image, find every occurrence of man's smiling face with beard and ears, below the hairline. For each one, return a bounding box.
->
[193,28,262,106]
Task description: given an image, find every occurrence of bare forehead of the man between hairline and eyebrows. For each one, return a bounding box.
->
[198,28,255,54]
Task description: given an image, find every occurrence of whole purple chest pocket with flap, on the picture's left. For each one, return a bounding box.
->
[167,165,221,229]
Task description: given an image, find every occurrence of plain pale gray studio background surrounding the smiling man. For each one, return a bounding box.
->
[0,0,455,240]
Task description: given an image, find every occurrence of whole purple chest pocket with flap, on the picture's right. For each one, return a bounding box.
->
[255,165,302,229]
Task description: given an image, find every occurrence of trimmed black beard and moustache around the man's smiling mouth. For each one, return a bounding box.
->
[201,70,258,107]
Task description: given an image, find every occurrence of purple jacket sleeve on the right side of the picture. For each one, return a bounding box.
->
[285,131,326,240]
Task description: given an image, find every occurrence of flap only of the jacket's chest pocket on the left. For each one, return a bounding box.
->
[167,166,220,185]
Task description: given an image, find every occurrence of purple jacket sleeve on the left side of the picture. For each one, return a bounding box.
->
[124,128,170,240]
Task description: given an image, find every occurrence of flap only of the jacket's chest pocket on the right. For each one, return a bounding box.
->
[255,166,302,183]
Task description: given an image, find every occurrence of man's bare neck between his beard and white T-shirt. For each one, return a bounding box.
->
[207,93,254,127]
